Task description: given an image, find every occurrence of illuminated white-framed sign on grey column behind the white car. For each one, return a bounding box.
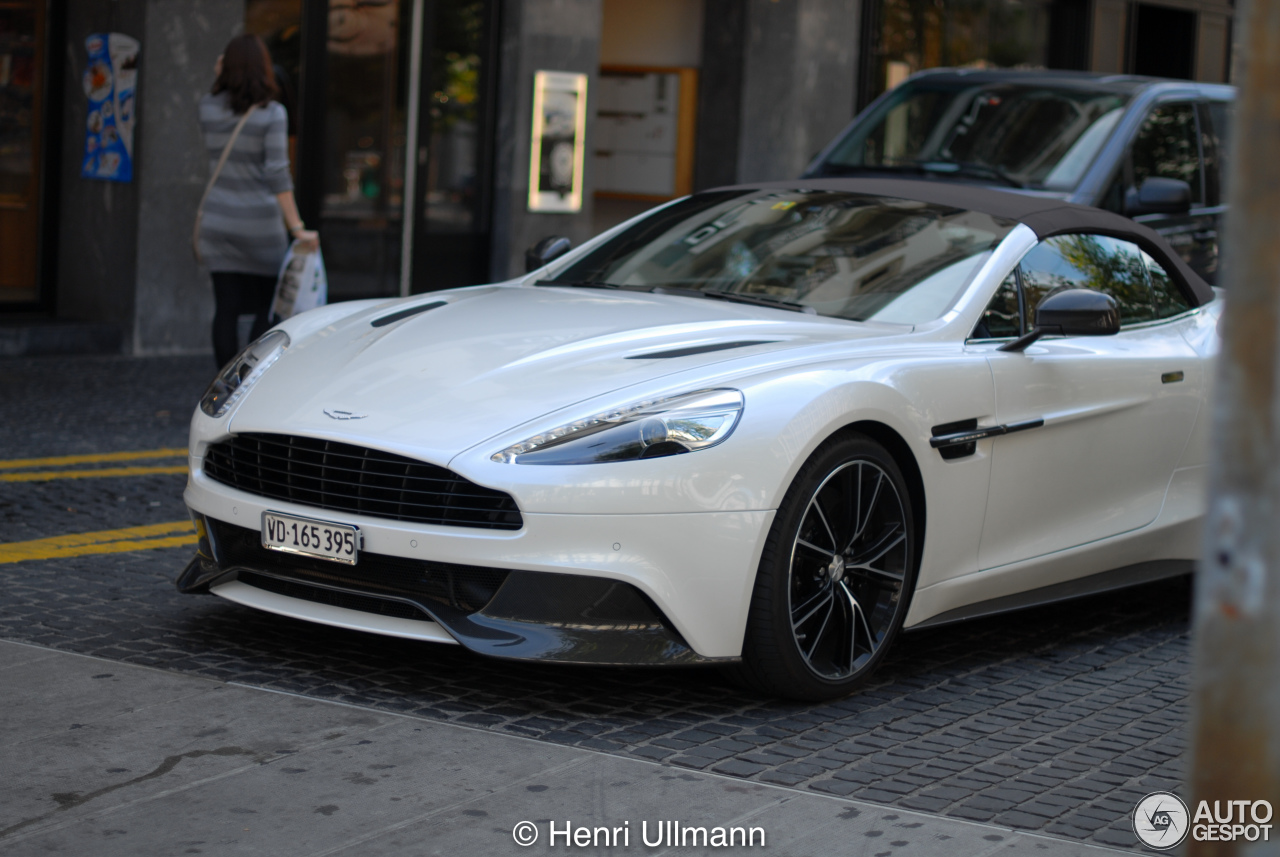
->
[529,72,586,214]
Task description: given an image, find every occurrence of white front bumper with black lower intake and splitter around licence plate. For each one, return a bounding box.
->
[178,471,773,664]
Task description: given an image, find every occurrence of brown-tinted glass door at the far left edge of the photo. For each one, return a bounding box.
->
[0,0,45,304]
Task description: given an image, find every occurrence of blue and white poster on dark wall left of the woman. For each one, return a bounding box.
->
[81,33,140,182]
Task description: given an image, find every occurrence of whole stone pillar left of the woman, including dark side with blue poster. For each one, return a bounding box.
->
[55,0,244,354]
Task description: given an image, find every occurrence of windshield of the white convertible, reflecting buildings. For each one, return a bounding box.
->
[539,189,1016,325]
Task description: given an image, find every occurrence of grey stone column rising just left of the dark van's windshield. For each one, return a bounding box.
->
[696,0,861,187]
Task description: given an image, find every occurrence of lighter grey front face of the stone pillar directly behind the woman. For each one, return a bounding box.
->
[132,0,244,354]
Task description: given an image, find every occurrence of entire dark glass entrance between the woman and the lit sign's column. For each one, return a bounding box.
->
[247,0,495,301]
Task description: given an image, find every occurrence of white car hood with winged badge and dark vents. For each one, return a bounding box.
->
[229,287,909,463]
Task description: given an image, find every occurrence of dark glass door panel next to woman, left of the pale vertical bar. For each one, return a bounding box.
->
[247,0,412,301]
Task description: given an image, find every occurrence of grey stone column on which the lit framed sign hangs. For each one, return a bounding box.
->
[490,0,602,280]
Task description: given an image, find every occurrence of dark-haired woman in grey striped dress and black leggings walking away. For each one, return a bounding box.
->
[197,35,319,366]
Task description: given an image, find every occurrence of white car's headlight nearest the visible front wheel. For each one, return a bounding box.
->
[492,390,742,464]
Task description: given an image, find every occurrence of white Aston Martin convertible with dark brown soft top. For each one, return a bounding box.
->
[178,179,1221,698]
